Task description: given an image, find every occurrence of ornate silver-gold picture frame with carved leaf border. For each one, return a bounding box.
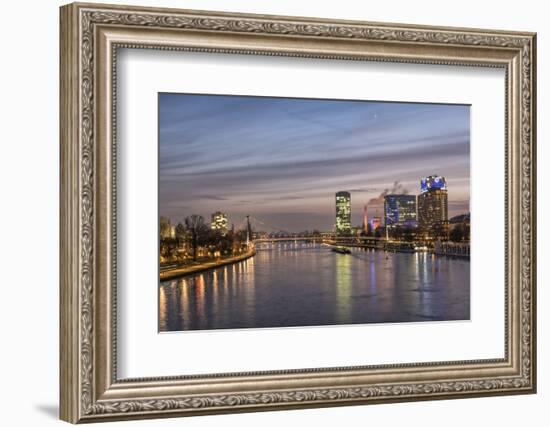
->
[60,4,536,423]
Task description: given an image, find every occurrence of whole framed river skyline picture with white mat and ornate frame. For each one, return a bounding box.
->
[60,4,536,423]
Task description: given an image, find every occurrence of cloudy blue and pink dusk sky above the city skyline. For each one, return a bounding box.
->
[159,94,470,232]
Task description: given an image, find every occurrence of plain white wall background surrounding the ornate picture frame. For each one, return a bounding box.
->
[0,0,550,427]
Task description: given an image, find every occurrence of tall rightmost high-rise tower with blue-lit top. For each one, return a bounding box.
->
[418,176,449,240]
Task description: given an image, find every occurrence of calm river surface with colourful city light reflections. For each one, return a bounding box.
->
[159,242,470,331]
